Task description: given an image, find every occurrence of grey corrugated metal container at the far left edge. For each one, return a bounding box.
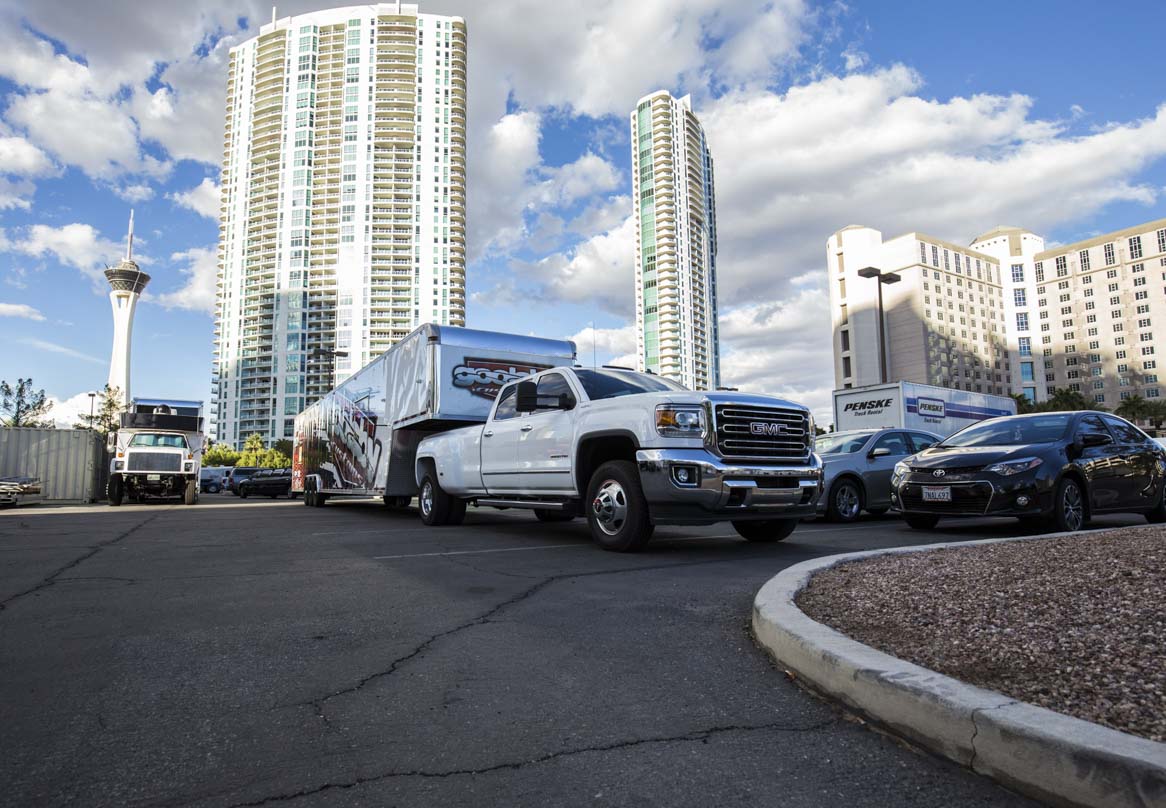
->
[0,427,106,503]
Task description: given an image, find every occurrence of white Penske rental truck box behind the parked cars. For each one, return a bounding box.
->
[834,381,1017,437]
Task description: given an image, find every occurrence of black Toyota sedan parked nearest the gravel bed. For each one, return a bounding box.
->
[891,412,1166,531]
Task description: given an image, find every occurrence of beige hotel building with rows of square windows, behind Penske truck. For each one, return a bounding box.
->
[827,219,1166,409]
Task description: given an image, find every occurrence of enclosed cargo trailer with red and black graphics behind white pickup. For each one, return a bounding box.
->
[292,324,575,505]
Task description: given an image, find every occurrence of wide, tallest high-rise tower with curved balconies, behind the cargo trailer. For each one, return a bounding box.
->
[215,2,466,445]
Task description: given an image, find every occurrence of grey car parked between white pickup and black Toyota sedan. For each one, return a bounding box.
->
[814,429,940,522]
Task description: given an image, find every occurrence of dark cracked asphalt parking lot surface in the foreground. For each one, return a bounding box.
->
[0,496,1144,807]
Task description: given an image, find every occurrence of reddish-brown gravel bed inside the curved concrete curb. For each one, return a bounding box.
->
[796,526,1166,742]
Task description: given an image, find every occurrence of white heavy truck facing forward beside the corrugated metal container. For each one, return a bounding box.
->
[106,399,205,506]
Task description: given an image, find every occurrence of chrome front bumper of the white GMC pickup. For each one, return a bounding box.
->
[635,449,822,525]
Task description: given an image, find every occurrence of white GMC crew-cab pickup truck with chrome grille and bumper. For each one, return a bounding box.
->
[415,367,822,551]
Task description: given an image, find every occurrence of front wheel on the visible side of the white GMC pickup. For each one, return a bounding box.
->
[585,461,655,553]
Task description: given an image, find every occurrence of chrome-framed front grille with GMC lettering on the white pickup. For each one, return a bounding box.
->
[714,405,810,462]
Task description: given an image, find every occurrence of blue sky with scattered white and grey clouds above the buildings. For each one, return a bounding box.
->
[0,0,1166,420]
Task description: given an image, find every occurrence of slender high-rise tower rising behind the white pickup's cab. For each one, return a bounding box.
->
[632,90,721,389]
